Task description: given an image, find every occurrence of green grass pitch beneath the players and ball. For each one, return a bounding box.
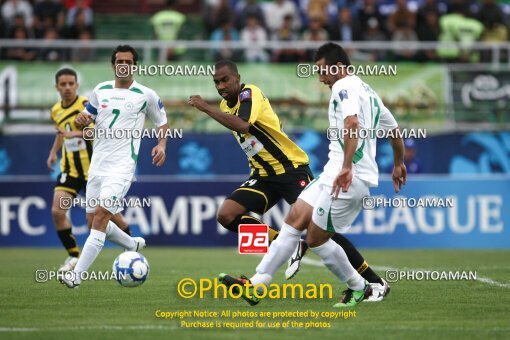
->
[0,248,510,340]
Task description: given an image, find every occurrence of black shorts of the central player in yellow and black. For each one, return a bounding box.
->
[227,165,313,215]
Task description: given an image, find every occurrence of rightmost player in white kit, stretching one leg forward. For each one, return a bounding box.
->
[220,43,406,307]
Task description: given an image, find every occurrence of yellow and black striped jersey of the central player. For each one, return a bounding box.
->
[220,84,309,177]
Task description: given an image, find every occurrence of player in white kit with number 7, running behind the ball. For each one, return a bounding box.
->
[62,45,168,288]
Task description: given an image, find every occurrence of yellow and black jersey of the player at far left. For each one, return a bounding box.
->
[51,96,92,180]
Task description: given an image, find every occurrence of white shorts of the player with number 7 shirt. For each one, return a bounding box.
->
[85,176,132,215]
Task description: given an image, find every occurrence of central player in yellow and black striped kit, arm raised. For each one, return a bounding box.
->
[189,60,382,284]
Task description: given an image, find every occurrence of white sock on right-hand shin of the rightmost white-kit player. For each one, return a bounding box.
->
[308,236,365,290]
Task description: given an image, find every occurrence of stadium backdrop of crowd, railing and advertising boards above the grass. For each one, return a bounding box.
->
[0,0,510,248]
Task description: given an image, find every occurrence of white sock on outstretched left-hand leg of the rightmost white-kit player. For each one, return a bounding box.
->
[250,223,301,285]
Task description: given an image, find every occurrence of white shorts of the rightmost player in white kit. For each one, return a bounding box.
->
[298,174,370,233]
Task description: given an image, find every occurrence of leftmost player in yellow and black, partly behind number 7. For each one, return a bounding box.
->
[46,68,130,271]
